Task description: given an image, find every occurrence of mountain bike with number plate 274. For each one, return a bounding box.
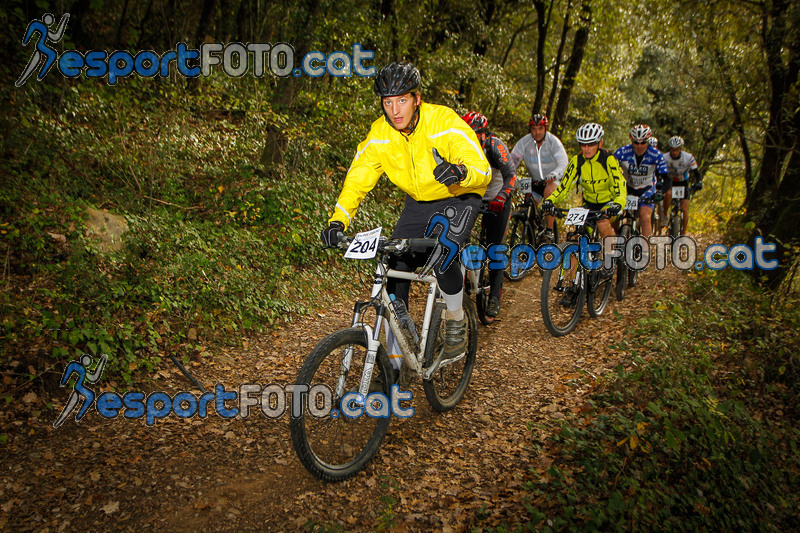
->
[541,208,614,337]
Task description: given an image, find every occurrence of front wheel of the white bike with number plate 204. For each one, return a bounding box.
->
[289,328,392,481]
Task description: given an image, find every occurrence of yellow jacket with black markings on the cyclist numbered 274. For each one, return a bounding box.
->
[546,148,627,207]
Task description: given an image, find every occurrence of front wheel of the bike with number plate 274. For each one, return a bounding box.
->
[541,264,586,337]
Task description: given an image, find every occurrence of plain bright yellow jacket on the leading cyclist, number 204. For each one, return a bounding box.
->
[329,102,492,228]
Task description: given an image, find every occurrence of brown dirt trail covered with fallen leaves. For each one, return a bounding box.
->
[0,269,682,531]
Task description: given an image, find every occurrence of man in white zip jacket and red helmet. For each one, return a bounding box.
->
[511,114,569,241]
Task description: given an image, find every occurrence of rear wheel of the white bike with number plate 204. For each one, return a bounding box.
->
[422,296,478,411]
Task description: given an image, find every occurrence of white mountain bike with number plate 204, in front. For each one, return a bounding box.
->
[290,232,478,481]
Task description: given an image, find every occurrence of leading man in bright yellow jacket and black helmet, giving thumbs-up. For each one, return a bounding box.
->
[321,62,492,359]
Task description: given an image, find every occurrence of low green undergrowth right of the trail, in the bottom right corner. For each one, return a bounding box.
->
[528,272,800,531]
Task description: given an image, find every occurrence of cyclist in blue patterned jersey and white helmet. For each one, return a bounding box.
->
[614,124,669,238]
